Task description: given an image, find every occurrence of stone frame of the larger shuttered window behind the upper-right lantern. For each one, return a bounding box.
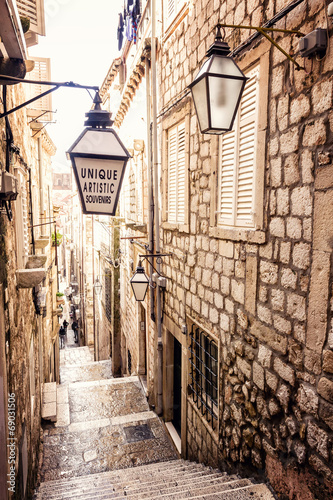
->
[209,44,270,244]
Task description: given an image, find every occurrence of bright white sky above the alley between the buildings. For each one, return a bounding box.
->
[27,0,123,164]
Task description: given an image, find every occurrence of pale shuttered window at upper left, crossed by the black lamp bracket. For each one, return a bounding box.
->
[27,57,52,121]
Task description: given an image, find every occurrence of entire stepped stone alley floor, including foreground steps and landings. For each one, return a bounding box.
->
[34,324,273,500]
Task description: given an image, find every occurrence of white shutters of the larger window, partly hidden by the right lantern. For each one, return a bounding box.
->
[218,66,259,227]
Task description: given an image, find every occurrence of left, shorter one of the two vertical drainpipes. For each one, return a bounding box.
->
[145,58,155,321]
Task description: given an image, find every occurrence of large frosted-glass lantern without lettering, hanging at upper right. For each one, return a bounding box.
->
[189,24,247,134]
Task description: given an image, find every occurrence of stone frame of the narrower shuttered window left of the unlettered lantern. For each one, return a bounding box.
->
[161,100,191,233]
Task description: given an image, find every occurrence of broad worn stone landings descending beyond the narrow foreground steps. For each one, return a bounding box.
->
[40,338,177,481]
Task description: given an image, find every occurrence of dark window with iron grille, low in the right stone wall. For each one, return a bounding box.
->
[190,324,218,429]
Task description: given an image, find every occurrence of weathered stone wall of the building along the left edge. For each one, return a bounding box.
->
[0,85,41,498]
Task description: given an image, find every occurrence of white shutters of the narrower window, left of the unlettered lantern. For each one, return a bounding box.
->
[168,120,186,223]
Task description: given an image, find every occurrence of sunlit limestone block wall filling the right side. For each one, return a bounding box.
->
[159,0,333,499]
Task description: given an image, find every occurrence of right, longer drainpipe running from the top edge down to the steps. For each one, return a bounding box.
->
[151,0,163,415]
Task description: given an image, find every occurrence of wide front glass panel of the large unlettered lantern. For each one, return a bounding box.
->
[208,76,244,130]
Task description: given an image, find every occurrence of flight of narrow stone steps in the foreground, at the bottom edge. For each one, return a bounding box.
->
[34,459,274,500]
